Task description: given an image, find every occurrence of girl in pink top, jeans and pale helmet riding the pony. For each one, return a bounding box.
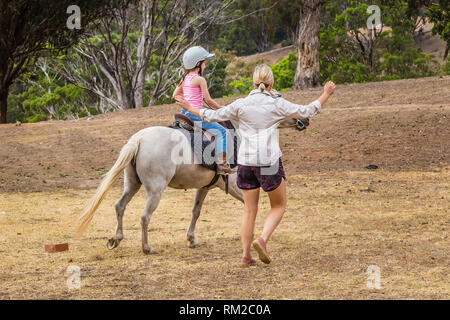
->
[172,46,231,174]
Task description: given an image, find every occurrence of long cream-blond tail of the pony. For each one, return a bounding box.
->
[77,131,146,236]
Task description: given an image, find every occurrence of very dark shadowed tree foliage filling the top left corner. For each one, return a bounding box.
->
[0,0,128,122]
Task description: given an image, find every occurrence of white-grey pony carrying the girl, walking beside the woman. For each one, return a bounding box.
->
[77,119,295,254]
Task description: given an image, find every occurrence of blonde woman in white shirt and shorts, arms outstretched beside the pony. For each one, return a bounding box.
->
[176,65,336,266]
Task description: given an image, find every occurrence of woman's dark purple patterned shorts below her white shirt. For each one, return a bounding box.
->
[236,158,286,192]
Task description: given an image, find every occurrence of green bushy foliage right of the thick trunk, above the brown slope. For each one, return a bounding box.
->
[320,0,439,83]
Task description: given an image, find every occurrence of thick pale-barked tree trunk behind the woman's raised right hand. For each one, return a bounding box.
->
[294,0,322,89]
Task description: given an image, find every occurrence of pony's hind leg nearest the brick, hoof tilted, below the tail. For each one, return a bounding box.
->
[107,164,141,249]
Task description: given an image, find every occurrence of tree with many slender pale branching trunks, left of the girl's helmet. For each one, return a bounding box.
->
[60,0,233,110]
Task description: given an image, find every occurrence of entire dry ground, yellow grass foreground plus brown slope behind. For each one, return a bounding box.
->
[0,77,450,299]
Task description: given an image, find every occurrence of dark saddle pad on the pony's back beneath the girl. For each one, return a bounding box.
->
[169,121,238,171]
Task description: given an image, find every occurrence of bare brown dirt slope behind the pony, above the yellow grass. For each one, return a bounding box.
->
[0,76,450,192]
